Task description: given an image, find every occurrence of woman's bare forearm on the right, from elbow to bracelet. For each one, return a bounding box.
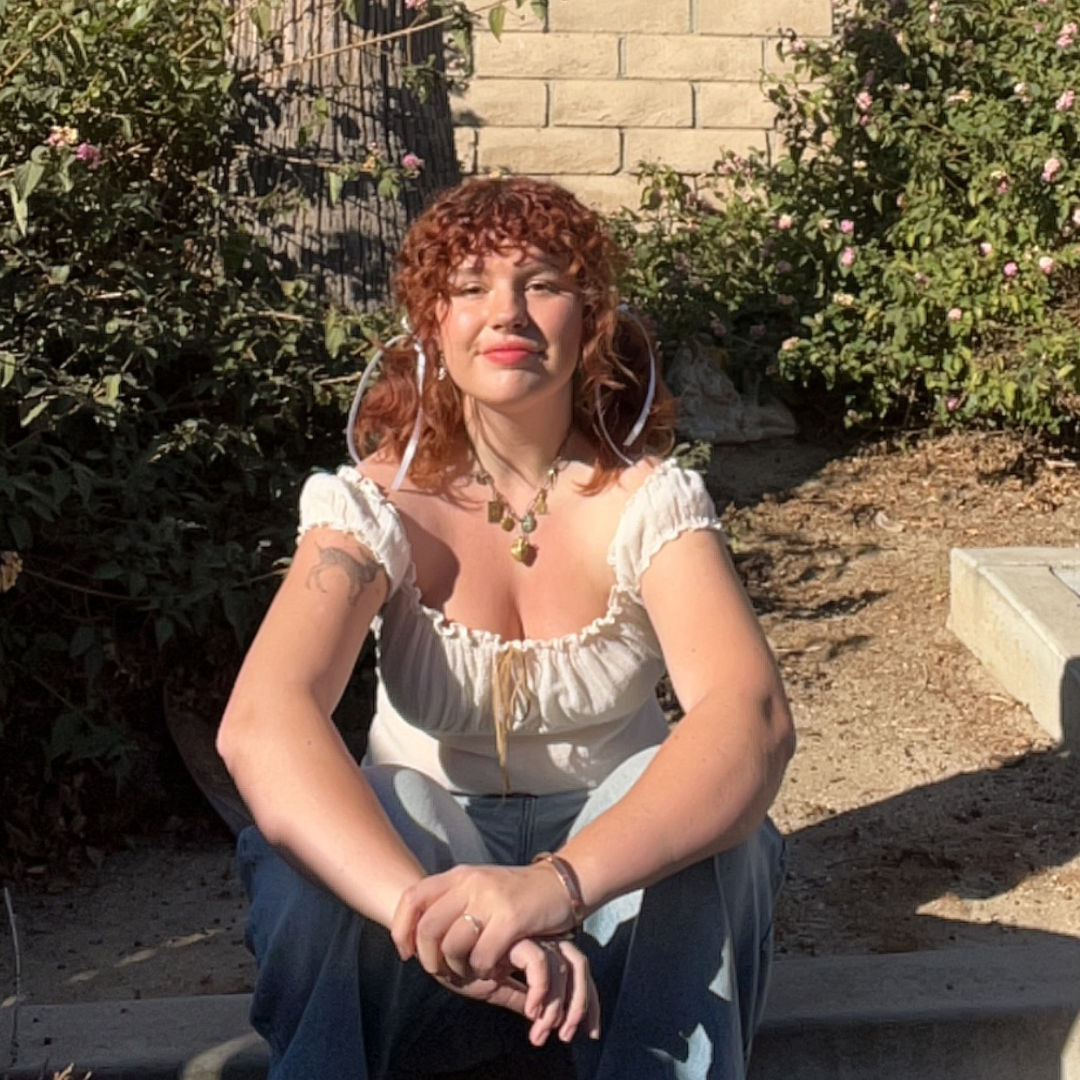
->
[559,691,794,910]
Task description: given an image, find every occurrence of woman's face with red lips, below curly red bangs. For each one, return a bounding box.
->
[438,248,582,413]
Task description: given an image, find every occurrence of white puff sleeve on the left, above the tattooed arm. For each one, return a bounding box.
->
[297,465,411,595]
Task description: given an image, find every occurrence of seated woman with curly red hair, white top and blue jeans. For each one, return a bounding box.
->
[219,179,794,1080]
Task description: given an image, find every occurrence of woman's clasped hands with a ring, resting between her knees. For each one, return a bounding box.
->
[390,864,600,1047]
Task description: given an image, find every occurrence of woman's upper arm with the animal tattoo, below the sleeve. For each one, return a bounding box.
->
[225,528,389,716]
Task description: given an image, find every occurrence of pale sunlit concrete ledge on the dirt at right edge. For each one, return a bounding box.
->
[948,548,1080,745]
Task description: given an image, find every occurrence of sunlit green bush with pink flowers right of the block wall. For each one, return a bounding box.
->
[622,0,1080,431]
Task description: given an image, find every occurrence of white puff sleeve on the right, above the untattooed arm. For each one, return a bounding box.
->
[610,458,724,599]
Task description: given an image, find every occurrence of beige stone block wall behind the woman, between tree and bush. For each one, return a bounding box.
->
[453,0,832,210]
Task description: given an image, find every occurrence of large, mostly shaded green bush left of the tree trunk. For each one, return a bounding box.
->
[0,0,380,859]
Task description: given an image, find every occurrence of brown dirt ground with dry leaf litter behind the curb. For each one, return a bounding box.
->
[0,425,1080,1007]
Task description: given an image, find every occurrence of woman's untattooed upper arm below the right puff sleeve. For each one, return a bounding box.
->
[642,529,791,739]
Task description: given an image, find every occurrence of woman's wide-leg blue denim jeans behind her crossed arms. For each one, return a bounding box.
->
[238,750,784,1080]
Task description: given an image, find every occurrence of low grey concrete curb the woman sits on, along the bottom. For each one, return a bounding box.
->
[0,935,1080,1080]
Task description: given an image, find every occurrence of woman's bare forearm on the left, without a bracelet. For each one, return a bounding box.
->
[218,699,424,927]
